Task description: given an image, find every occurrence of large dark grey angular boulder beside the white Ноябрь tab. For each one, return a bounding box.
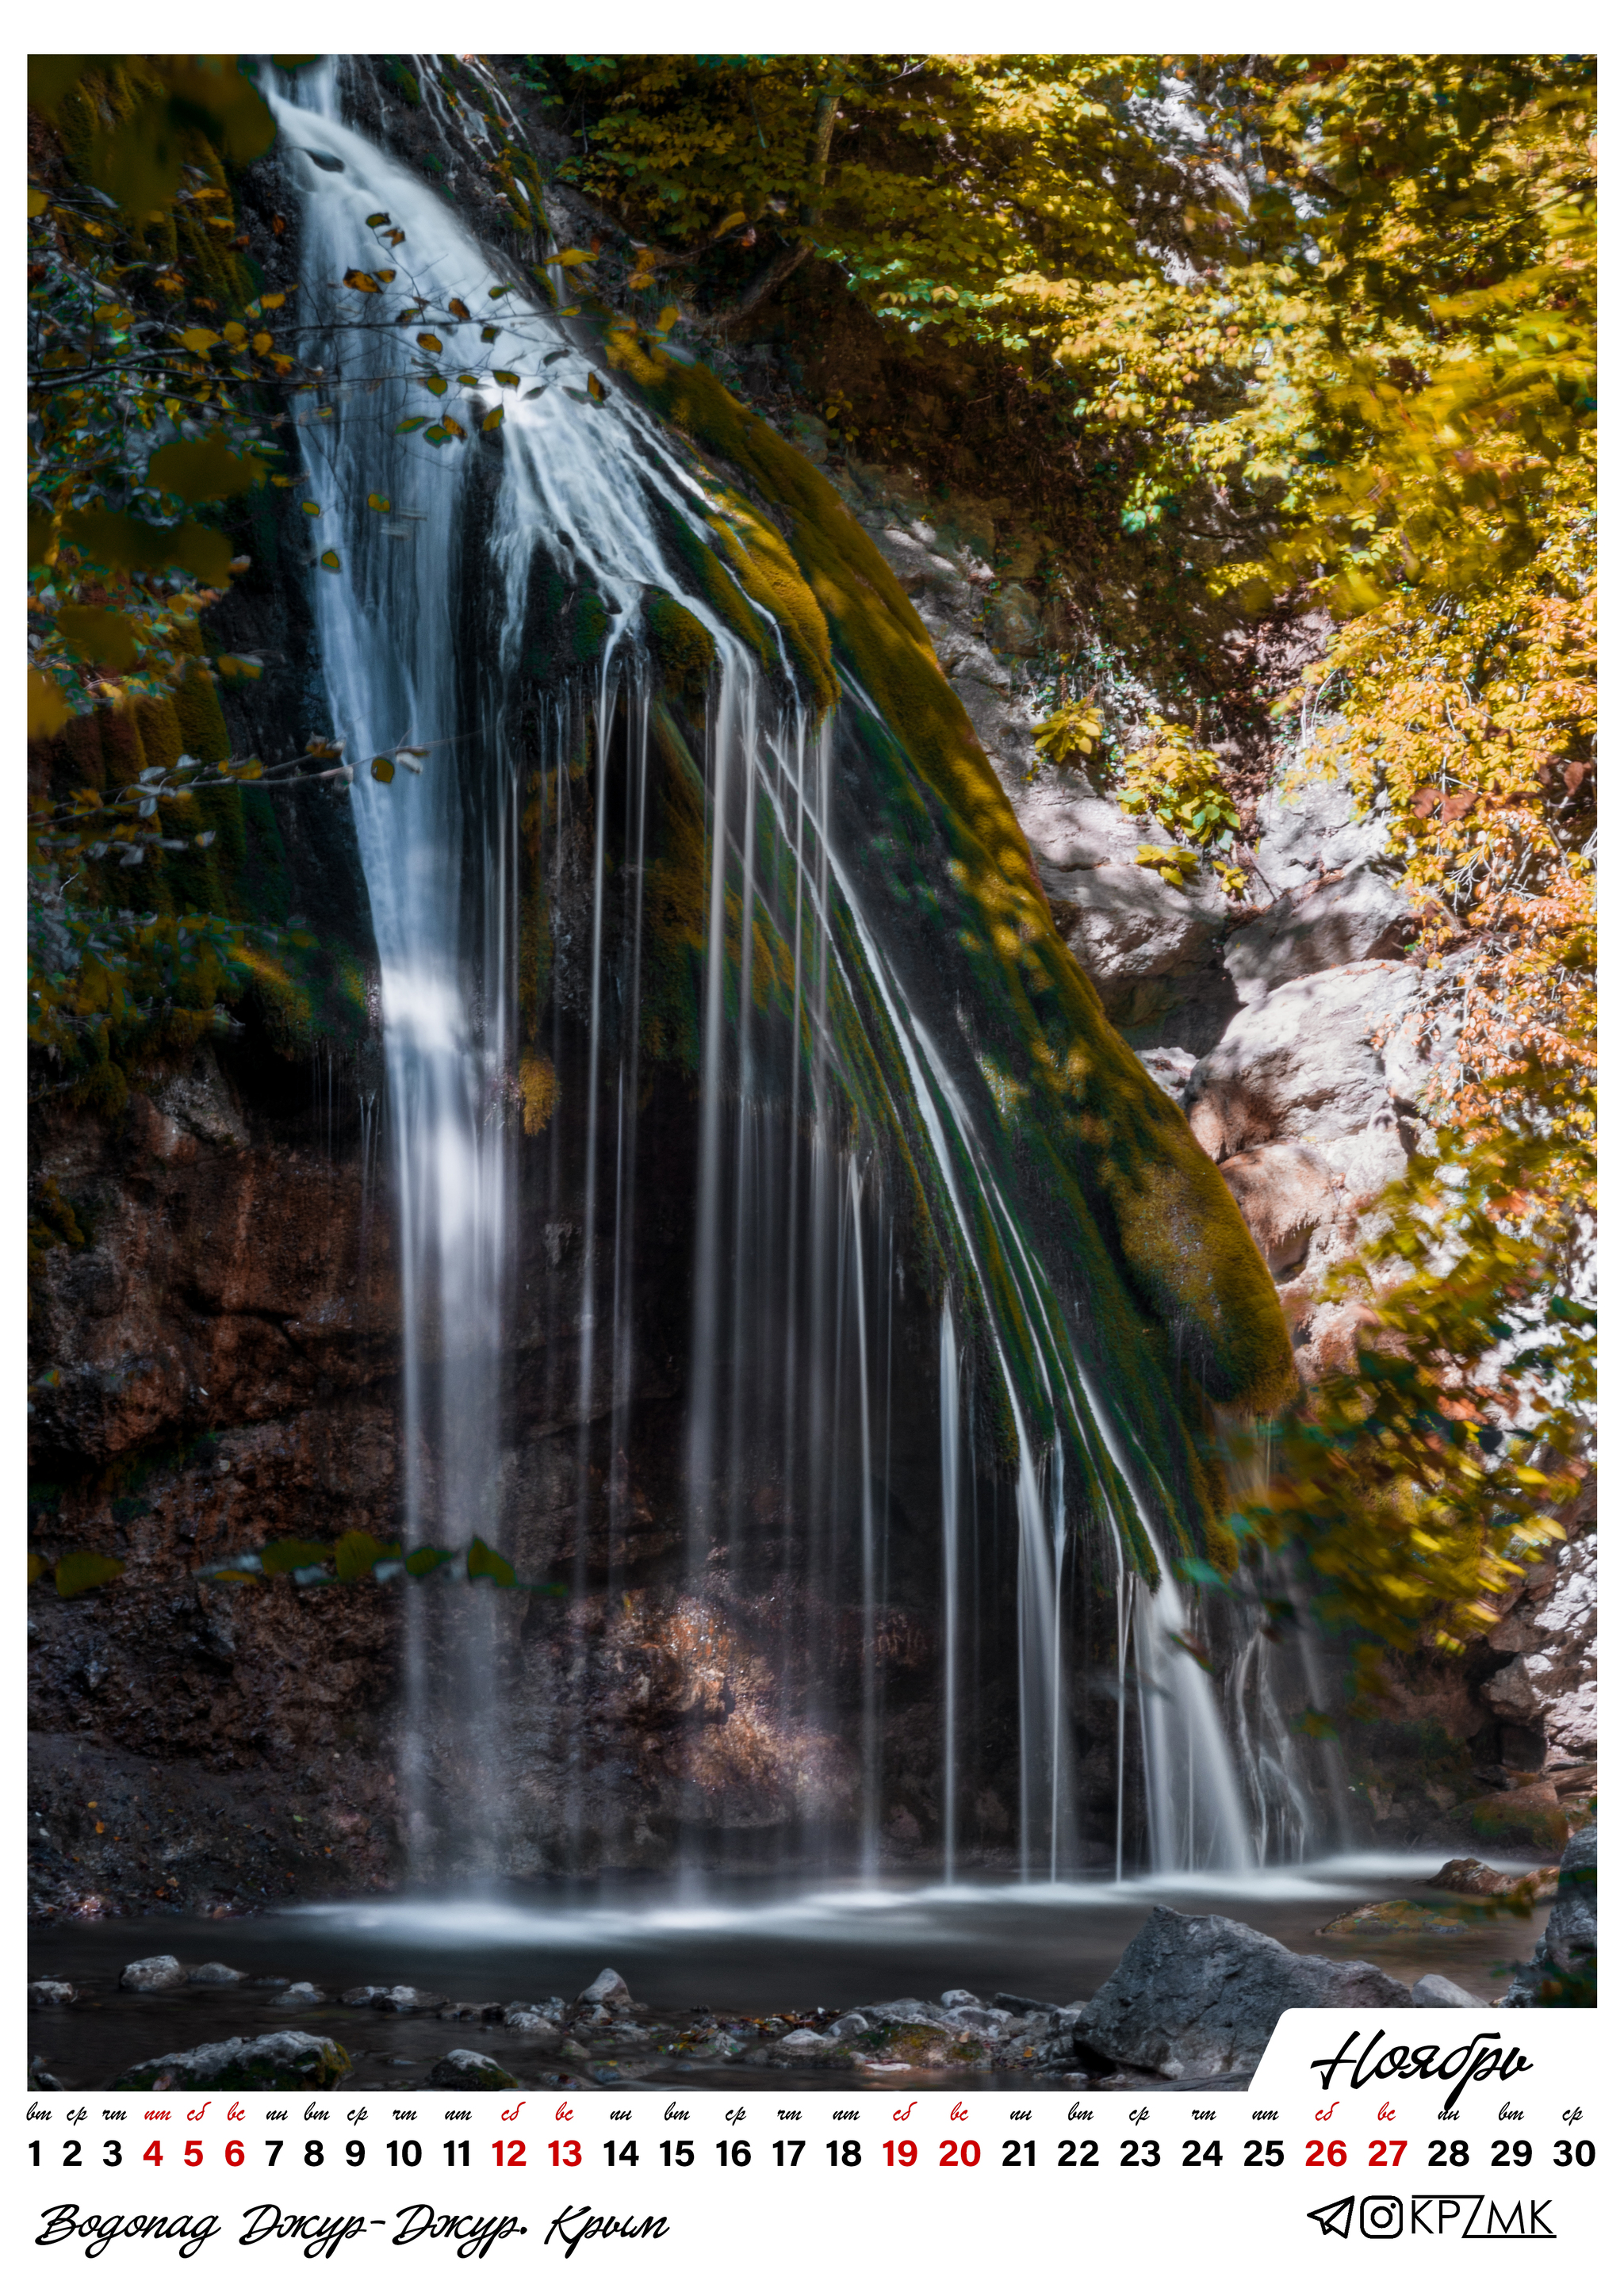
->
[1075,1906,1411,2080]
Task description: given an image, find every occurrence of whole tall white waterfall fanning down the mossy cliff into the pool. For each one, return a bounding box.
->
[274,62,1284,1881]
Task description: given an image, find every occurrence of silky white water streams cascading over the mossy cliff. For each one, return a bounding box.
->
[276,67,1313,1878]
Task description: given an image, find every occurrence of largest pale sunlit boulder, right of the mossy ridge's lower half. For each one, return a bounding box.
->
[1188,960,1422,1181]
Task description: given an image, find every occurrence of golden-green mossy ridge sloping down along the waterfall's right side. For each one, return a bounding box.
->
[609,333,1296,1433]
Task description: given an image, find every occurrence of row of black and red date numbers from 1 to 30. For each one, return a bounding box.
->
[28,2137,1596,2168]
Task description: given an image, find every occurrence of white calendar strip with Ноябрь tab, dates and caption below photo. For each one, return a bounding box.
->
[11,2009,1611,2289]
